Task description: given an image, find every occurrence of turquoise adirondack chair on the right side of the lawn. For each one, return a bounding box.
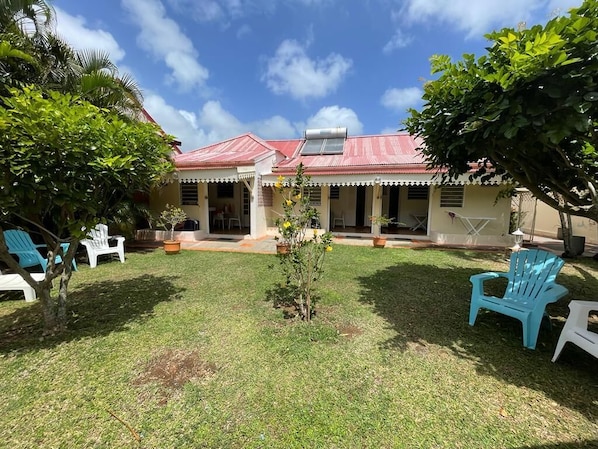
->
[469,250,568,349]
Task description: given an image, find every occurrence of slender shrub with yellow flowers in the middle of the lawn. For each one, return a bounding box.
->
[275,164,332,321]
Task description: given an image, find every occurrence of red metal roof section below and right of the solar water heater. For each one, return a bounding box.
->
[272,134,426,175]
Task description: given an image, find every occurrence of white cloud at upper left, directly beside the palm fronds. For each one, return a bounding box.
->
[54,7,125,64]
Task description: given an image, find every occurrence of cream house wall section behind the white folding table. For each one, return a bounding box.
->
[428,185,514,246]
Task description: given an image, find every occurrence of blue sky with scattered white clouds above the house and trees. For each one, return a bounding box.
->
[51,0,582,151]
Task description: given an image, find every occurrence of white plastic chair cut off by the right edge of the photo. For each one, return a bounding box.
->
[552,301,598,362]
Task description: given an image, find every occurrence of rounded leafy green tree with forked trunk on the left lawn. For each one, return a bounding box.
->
[0,87,173,329]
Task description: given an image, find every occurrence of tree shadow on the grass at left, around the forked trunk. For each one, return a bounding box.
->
[0,275,182,353]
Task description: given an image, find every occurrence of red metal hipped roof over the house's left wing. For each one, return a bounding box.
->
[174,133,276,170]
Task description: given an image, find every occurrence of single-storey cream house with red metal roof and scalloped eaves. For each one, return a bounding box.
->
[150,128,513,246]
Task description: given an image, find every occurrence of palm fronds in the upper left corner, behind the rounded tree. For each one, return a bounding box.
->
[0,0,143,118]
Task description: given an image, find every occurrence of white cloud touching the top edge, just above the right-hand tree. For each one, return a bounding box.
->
[404,0,552,37]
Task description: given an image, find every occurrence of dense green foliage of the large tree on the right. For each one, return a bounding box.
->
[405,0,598,220]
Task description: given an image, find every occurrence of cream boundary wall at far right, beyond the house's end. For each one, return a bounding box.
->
[521,201,598,243]
